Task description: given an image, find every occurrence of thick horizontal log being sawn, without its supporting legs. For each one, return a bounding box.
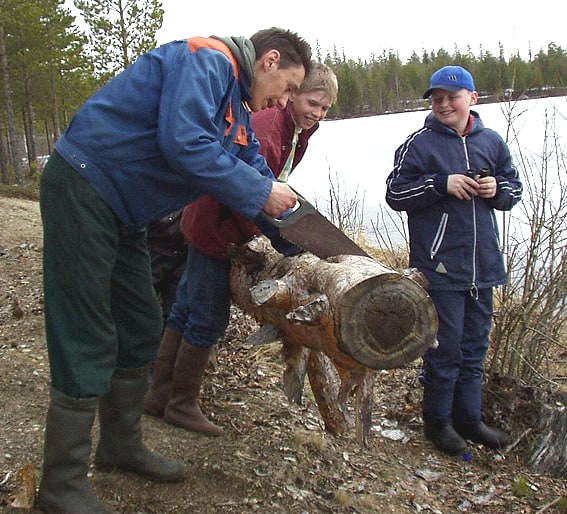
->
[231,237,437,370]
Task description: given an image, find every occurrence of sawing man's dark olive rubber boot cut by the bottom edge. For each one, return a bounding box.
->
[38,389,111,514]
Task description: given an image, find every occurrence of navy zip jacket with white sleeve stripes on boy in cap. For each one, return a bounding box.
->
[386,111,522,291]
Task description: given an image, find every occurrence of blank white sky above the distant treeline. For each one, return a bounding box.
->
[157,0,567,62]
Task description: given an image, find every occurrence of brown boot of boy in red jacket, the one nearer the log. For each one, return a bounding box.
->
[163,340,224,436]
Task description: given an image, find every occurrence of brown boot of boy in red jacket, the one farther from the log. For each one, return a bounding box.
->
[144,328,182,417]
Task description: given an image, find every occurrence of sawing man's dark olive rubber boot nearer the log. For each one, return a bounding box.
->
[95,368,184,482]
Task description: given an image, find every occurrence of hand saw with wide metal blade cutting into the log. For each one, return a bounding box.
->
[262,191,370,259]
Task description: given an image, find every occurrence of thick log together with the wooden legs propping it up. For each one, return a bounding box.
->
[231,237,438,444]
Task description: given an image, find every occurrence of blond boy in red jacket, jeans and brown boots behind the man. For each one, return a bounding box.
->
[144,63,338,436]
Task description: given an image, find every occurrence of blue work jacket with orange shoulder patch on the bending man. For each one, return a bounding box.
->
[56,38,274,227]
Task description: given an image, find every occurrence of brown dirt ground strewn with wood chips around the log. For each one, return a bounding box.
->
[0,196,566,514]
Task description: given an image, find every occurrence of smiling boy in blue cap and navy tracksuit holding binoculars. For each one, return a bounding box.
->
[386,66,522,454]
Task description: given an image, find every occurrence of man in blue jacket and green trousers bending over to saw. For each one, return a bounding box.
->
[39,28,311,514]
